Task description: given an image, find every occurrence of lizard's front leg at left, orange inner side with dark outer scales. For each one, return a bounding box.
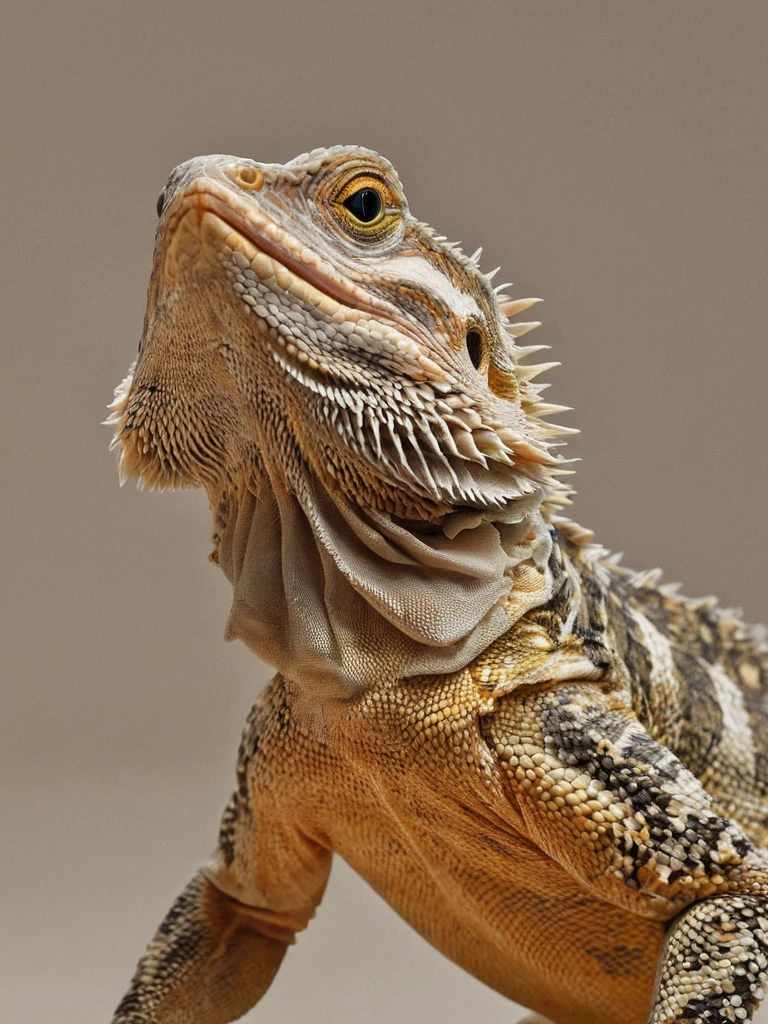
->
[113,679,332,1024]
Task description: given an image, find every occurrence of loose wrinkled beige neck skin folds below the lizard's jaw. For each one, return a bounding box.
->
[219,452,553,701]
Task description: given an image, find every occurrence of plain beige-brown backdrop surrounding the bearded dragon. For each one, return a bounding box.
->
[0,0,768,1024]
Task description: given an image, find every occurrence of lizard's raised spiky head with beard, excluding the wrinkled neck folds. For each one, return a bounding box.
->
[112,146,562,540]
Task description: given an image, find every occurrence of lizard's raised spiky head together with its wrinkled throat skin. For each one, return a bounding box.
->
[111,146,566,686]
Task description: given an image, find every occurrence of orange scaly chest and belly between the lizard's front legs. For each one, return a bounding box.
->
[309,680,663,1021]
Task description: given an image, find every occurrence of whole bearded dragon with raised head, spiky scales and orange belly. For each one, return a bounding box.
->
[105,146,768,1024]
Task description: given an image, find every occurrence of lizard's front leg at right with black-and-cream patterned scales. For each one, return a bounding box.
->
[486,683,768,1024]
